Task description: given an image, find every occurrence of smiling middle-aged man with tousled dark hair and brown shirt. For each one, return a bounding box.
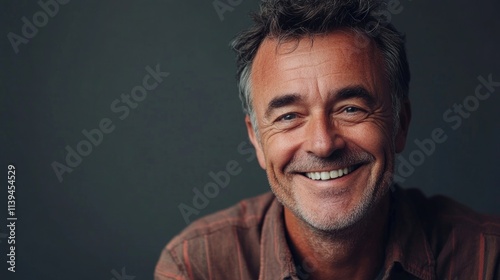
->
[155,0,500,280]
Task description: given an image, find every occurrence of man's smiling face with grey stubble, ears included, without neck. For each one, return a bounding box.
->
[246,30,409,231]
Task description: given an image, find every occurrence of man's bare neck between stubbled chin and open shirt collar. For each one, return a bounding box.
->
[284,194,390,280]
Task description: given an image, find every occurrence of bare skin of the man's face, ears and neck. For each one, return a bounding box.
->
[246,30,410,279]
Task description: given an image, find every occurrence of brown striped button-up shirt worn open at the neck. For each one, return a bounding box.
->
[155,187,500,280]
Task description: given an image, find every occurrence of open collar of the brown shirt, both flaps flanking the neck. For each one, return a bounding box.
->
[259,186,435,280]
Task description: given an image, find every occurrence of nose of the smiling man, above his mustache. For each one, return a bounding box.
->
[305,115,345,158]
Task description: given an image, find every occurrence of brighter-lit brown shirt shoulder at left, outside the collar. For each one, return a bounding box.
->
[155,192,275,279]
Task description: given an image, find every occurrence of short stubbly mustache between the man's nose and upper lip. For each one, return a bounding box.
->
[285,148,375,172]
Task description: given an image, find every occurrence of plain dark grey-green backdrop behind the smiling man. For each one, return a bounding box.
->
[0,0,500,280]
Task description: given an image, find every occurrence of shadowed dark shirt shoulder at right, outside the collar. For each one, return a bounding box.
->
[401,186,500,279]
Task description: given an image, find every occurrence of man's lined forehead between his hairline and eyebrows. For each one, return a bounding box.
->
[251,30,387,109]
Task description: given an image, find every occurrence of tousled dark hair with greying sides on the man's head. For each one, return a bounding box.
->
[231,0,410,134]
